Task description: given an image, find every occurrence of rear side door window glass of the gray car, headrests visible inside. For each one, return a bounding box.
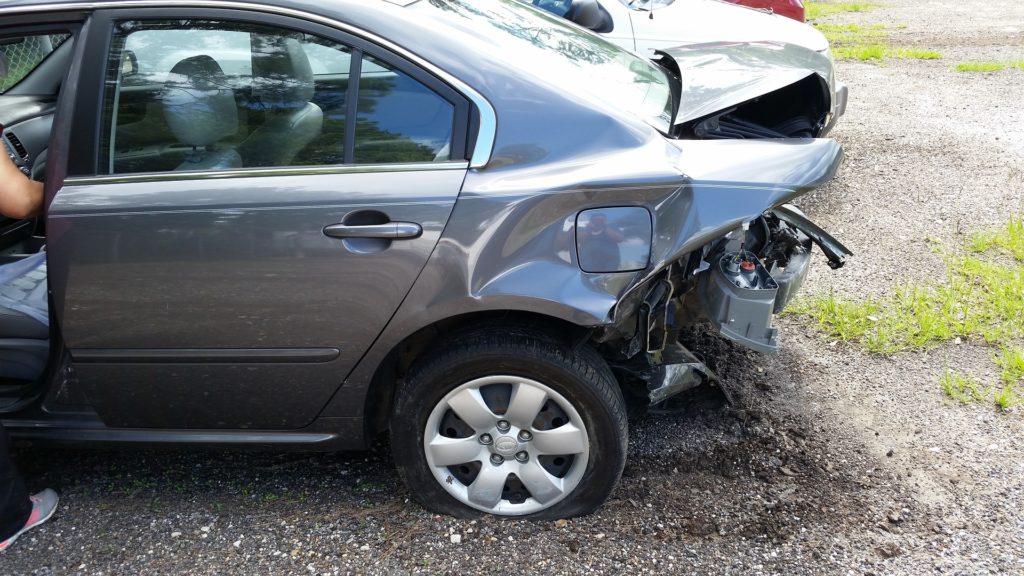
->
[99,19,456,174]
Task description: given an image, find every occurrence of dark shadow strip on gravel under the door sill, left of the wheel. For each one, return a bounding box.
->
[14,446,406,525]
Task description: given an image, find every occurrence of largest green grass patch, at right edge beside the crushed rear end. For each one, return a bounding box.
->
[794,217,1024,410]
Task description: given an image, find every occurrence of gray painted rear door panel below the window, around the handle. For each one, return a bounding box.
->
[49,166,465,429]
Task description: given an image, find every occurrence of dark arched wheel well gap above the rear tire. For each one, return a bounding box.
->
[364,311,592,441]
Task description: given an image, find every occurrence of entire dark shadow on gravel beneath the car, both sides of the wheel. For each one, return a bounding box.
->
[6,331,905,566]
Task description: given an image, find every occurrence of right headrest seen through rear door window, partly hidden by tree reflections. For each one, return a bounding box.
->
[252,34,313,110]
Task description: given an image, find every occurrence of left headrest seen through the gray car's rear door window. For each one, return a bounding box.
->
[161,54,239,147]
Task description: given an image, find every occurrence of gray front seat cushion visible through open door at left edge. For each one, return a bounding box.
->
[0,253,50,382]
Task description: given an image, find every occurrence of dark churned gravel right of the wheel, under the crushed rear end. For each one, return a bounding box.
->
[602,330,897,542]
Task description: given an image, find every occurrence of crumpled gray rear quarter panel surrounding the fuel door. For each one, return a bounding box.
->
[325,134,843,416]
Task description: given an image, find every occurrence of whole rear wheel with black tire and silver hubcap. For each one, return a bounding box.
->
[390,330,627,519]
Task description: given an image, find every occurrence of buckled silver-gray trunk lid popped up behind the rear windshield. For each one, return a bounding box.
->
[656,42,833,125]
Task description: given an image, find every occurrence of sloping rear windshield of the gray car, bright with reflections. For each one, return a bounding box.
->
[413,0,673,132]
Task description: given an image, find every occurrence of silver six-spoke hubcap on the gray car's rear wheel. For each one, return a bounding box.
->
[423,376,590,516]
